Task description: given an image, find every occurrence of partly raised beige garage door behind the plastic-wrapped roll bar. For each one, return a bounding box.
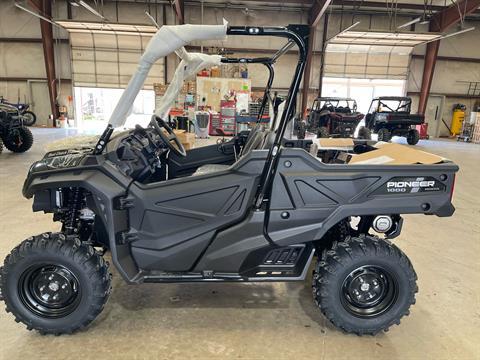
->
[58,21,164,89]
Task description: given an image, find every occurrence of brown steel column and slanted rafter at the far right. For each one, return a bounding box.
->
[418,0,480,114]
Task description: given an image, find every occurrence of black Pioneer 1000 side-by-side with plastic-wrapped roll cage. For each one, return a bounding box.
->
[1,25,458,334]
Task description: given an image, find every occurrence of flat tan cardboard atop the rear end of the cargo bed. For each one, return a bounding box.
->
[348,142,446,165]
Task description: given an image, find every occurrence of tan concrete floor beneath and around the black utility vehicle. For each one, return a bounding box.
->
[0,129,480,359]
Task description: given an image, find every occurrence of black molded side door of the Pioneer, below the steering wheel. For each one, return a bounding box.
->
[129,159,261,271]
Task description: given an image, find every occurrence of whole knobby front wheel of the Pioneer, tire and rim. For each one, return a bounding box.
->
[0,233,111,335]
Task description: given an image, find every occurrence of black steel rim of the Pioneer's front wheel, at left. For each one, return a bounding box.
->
[19,264,80,318]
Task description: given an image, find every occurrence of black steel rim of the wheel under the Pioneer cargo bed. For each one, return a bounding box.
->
[341,265,398,317]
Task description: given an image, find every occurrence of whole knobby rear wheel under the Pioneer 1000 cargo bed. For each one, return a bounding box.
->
[312,236,418,335]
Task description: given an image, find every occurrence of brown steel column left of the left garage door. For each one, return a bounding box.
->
[30,0,59,127]
